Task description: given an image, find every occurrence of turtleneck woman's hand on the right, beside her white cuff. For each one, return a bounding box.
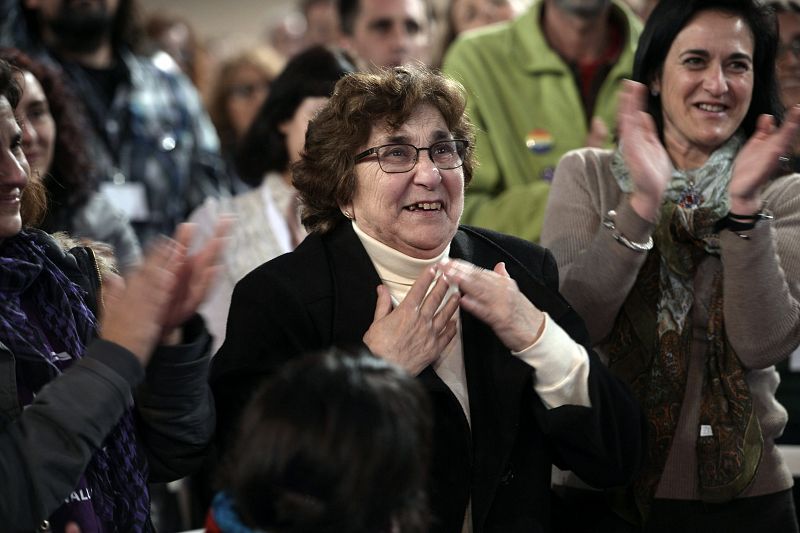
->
[442,259,544,352]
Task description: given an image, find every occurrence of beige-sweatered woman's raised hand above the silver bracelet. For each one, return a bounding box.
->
[617,80,672,222]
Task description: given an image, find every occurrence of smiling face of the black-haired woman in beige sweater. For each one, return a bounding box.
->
[651,11,753,168]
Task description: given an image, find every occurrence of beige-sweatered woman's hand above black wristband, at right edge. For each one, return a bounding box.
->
[728,105,800,215]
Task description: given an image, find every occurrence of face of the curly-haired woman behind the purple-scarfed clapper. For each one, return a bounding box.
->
[17,71,56,175]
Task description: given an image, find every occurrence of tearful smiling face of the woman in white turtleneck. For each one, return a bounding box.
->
[341,104,464,259]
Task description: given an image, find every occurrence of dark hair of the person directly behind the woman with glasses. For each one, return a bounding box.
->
[236,46,355,187]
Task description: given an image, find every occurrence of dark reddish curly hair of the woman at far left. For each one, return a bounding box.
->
[0,48,94,211]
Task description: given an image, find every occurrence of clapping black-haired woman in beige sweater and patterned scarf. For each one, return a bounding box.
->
[542,0,800,532]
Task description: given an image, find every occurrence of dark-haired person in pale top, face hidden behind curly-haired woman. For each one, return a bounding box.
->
[190,46,353,352]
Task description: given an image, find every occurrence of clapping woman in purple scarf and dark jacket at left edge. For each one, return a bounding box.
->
[0,61,224,533]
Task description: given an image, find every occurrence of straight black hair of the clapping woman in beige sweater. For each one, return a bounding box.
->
[633,0,783,140]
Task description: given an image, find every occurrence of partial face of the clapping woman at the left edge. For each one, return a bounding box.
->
[0,96,30,240]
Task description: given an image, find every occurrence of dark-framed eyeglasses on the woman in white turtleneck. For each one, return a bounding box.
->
[355,139,469,174]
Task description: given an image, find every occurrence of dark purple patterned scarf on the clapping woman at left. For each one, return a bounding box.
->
[0,231,152,533]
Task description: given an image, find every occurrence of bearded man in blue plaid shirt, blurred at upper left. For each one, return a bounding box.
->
[0,0,230,244]
